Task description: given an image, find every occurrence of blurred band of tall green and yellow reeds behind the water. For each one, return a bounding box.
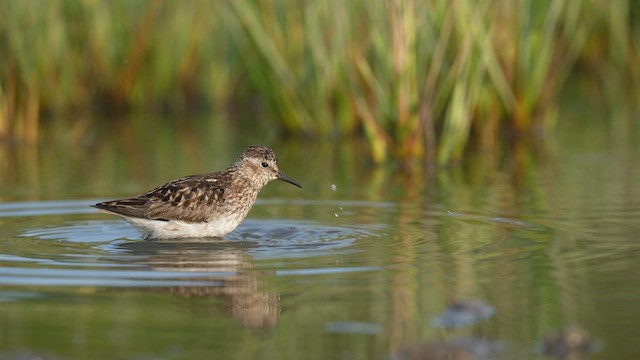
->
[0,0,640,163]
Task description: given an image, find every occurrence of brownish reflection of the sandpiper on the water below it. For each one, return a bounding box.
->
[122,242,280,329]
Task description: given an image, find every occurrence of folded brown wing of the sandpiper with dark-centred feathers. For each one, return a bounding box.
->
[94,175,224,222]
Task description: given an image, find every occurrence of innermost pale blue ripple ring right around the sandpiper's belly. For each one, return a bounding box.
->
[21,220,381,258]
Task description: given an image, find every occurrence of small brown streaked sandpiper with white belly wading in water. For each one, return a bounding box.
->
[93,146,302,239]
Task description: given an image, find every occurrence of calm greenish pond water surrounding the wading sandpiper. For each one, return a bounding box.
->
[0,111,640,359]
